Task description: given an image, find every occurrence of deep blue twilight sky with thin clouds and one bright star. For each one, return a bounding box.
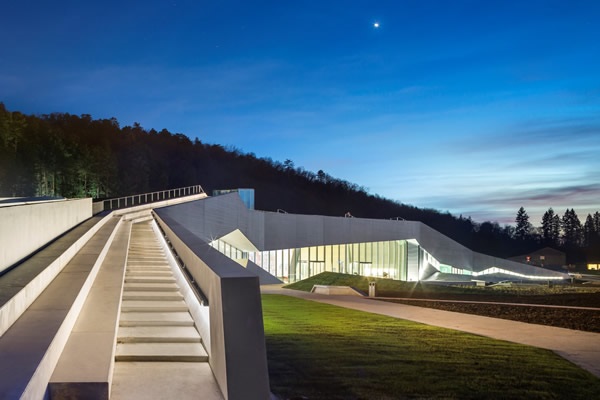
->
[0,0,600,226]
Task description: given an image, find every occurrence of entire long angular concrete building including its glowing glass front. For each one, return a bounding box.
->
[155,192,569,283]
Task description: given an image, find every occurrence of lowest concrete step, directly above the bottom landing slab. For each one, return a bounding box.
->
[115,343,208,362]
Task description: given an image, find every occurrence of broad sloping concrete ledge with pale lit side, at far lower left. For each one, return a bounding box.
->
[0,218,118,399]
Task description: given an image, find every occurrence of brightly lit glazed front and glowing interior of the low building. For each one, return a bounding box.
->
[210,230,568,283]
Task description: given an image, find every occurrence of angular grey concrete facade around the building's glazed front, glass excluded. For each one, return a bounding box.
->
[155,194,568,281]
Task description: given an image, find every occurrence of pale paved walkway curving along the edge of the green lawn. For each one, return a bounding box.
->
[261,285,600,378]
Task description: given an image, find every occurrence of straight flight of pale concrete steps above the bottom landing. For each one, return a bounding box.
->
[115,221,208,362]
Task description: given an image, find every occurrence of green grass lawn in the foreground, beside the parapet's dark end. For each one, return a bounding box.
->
[262,295,600,400]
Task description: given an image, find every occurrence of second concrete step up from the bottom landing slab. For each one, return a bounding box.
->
[117,326,201,343]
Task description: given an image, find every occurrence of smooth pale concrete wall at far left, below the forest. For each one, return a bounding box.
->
[0,198,92,273]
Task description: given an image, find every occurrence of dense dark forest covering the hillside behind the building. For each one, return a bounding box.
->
[0,103,600,261]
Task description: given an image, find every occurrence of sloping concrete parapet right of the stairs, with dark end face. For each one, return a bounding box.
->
[155,210,270,400]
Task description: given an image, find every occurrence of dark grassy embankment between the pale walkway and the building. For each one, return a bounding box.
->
[286,272,600,332]
